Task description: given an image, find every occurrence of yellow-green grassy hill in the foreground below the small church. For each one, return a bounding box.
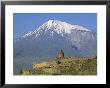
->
[20,57,97,75]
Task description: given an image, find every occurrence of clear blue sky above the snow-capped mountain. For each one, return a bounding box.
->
[13,13,97,38]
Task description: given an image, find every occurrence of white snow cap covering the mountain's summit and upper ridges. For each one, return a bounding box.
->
[23,20,90,37]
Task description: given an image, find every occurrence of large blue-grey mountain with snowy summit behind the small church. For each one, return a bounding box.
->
[14,20,97,60]
